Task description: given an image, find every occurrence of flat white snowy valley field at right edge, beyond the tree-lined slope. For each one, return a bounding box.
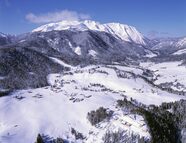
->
[141,62,186,91]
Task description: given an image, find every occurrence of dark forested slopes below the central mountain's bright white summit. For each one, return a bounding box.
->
[18,29,153,63]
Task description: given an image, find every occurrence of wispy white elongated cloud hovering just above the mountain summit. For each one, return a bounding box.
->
[25,10,90,23]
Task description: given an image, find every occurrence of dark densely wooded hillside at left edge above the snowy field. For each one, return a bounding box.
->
[0,47,64,90]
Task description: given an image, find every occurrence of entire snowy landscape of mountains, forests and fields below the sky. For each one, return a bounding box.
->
[0,21,186,143]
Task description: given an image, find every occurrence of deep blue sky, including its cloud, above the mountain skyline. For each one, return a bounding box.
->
[0,0,186,37]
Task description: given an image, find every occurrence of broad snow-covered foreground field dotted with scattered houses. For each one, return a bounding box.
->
[0,64,186,143]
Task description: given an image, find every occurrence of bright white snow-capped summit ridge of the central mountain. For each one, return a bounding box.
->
[33,20,146,45]
